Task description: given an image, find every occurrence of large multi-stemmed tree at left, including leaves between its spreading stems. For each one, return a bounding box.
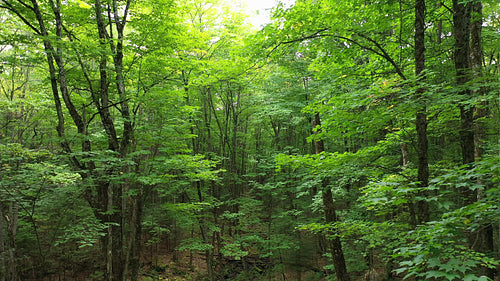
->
[2,0,164,280]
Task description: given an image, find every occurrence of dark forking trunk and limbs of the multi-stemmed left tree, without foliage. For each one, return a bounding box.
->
[3,0,141,281]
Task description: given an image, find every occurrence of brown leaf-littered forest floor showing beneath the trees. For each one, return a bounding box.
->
[38,236,385,281]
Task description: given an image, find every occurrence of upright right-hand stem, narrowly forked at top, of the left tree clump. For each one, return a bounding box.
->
[95,0,136,280]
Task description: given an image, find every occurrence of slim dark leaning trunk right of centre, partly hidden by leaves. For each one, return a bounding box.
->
[313,113,350,281]
